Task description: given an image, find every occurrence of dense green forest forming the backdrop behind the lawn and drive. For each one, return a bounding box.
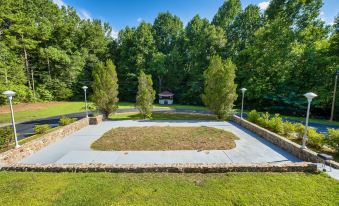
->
[0,0,339,116]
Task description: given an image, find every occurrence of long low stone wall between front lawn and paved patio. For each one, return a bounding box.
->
[0,162,317,173]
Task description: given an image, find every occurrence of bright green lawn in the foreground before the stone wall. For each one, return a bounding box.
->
[0,172,339,206]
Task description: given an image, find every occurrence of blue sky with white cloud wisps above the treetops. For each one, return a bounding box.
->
[53,0,339,37]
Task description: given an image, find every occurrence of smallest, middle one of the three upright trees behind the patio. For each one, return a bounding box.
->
[136,71,155,119]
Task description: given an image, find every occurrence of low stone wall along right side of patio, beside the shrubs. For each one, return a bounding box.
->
[233,116,339,169]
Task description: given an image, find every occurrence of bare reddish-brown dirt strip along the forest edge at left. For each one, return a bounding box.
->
[0,102,65,114]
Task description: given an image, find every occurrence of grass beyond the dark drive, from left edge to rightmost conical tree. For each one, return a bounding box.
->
[0,102,206,124]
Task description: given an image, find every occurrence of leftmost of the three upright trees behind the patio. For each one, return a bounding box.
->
[92,60,119,118]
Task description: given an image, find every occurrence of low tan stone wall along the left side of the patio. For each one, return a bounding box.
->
[0,118,89,166]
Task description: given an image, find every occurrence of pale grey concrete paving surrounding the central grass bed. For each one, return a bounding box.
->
[21,120,300,164]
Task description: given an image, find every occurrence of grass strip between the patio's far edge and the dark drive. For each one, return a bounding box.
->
[109,112,217,121]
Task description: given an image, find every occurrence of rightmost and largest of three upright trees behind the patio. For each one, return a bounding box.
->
[202,56,237,119]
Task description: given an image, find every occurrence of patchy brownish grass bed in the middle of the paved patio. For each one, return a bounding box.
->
[91,126,238,151]
